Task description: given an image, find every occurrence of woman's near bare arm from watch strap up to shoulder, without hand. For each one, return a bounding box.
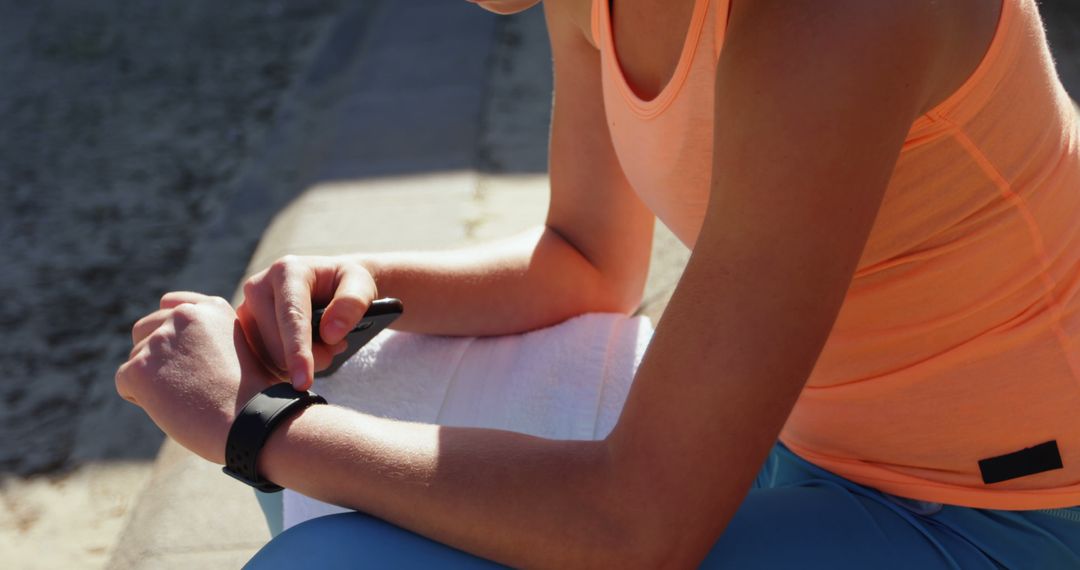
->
[261,0,936,568]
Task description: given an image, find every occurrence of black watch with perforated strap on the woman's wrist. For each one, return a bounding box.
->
[221,382,326,492]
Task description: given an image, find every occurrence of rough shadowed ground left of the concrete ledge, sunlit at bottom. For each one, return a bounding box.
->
[0,0,340,568]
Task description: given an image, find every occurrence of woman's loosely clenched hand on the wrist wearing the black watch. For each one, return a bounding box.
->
[117,293,276,463]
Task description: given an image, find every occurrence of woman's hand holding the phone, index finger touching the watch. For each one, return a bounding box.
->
[237,256,377,390]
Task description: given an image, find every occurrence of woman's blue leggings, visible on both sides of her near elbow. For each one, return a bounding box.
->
[245,443,1080,570]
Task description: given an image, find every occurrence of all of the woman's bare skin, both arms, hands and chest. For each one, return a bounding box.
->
[117,0,1000,568]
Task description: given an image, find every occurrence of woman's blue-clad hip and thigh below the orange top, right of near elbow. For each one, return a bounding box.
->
[725,443,1080,569]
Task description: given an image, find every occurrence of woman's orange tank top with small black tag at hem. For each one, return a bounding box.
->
[592,0,1080,510]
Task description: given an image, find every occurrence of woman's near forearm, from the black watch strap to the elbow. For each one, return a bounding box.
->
[259,406,647,568]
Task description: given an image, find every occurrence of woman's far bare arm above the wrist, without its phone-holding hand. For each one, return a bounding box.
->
[356,2,653,335]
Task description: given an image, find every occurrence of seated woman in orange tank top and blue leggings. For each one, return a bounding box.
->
[117,0,1080,568]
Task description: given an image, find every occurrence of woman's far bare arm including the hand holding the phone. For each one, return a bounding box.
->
[238,2,653,382]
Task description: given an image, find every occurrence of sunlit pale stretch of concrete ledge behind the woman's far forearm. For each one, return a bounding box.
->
[247,171,548,267]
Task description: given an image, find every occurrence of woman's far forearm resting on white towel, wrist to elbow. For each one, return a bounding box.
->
[355,226,636,336]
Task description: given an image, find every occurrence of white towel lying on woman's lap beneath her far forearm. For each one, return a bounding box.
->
[283,313,652,528]
